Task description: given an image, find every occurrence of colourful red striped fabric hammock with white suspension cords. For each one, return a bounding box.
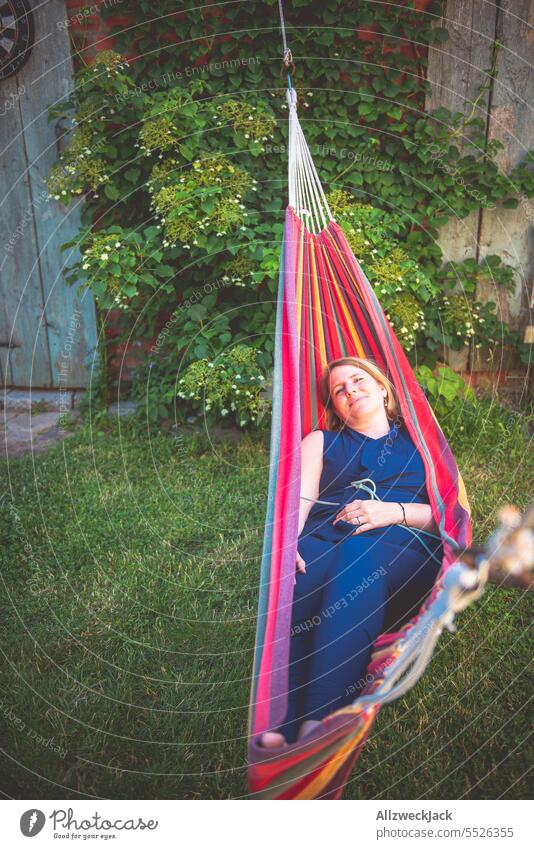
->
[249,87,476,799]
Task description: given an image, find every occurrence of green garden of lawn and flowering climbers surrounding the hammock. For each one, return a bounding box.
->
[0,0,534,799]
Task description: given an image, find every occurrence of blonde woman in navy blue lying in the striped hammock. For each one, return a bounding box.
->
[262,357,443,748]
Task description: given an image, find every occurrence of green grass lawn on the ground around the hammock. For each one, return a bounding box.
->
[0,408,533,799]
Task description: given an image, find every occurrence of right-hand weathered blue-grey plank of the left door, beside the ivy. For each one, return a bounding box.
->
[16,0,96,388]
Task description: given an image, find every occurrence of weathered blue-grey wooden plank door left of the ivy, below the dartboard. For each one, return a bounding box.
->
[0,0,97,389]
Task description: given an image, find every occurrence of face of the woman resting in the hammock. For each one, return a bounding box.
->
[329,365,386,425]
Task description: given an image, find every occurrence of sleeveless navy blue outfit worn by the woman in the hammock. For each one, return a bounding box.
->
[281,423,443,742]
